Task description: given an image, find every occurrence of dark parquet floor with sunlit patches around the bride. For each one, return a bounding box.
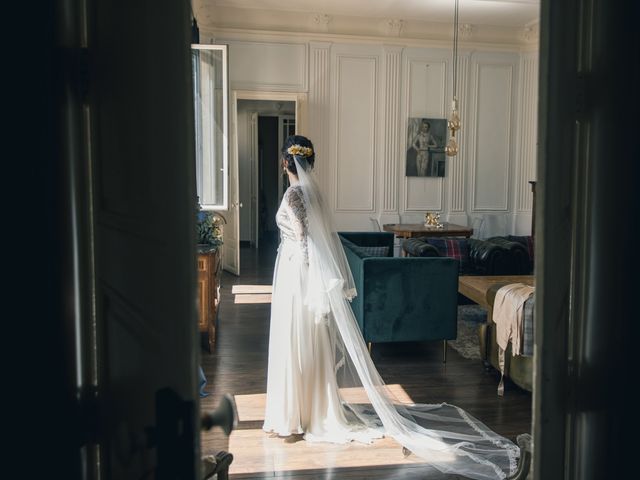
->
[201,247,531,480]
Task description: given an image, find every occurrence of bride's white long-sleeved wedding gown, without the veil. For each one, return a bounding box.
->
[264,185,382,443]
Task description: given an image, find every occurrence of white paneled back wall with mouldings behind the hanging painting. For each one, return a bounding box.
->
[222,35,538,236]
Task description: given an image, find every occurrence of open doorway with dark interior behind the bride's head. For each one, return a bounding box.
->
[237,99,296,253]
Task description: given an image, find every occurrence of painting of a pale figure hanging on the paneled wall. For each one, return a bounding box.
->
[406,118,447,177]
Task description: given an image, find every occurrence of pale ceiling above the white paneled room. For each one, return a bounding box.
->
[204,0,540,27]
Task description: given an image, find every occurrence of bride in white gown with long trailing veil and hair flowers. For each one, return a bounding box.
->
[263,135,519,479]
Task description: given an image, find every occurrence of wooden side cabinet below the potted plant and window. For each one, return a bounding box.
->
[198,250,221,353]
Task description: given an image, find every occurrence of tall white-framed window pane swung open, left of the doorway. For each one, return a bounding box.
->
[191,45,229,210]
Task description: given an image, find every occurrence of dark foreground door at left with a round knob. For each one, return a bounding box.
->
[87,0,199,480]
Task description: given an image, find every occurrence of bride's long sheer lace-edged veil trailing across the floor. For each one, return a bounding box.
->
[294,156,519,480]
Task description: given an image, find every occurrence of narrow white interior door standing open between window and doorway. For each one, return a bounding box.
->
[222,91,242,275]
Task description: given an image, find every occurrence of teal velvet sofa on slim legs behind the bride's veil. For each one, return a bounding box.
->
[339,232,459,361]
